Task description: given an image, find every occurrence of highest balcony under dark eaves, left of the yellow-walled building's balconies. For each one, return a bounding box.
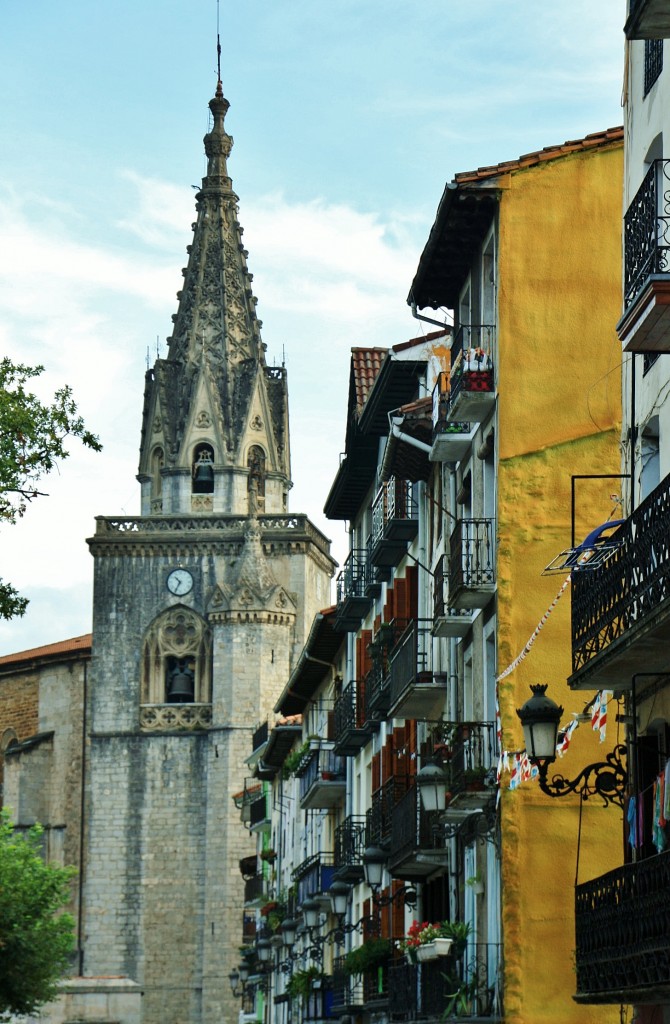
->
[370,476,419,575]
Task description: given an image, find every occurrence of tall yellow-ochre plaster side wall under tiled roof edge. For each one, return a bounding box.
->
[497,146,622,1024]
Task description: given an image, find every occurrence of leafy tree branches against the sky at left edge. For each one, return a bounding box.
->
[0,358,101,618]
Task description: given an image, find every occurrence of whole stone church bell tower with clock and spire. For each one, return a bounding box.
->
[83,75,334,1024]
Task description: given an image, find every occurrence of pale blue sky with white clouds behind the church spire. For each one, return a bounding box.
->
[0,0,625,654]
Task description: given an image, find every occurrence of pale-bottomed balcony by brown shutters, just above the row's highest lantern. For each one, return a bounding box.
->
[388,618,446,721]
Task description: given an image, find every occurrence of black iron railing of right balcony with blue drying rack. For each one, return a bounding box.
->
[572,468,670,672]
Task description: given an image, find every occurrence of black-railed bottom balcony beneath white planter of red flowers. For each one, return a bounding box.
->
[388,942,504,1022]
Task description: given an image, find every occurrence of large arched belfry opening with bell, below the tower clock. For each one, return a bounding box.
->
[141,606,211,705]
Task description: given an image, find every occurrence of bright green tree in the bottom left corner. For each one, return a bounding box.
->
[0,811,76,1020]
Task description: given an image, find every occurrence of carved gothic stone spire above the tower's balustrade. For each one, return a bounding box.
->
[139,82,290,514]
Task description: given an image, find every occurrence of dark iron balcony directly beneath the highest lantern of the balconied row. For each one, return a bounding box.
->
[388,783,447,882]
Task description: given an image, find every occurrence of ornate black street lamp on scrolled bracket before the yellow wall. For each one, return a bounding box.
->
[516,684,628,807]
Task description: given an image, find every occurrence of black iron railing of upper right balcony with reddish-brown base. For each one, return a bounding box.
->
[624,160,670,308]
